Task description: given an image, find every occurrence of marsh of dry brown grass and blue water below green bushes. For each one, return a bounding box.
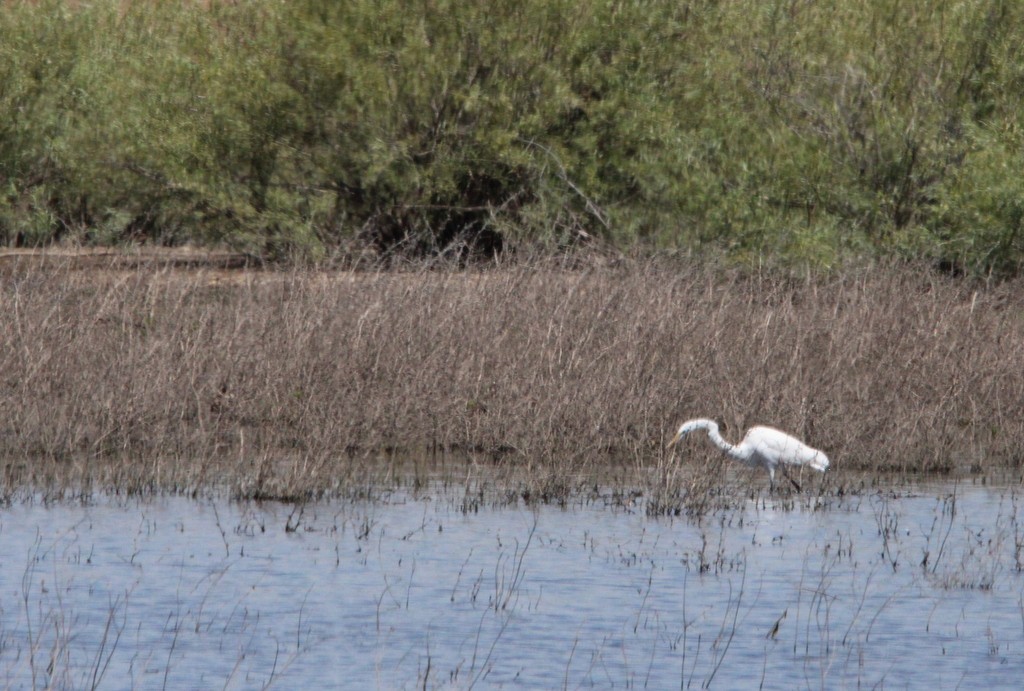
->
[0,257,1024,688]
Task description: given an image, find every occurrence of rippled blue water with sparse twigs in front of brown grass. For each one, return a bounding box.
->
[0,486,1024,688]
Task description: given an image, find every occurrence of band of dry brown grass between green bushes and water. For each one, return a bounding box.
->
[0,251,1024,500]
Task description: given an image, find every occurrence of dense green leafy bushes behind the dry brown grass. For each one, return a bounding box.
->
[0,0,1024,273]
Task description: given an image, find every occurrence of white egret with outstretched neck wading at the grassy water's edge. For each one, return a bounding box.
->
[669,418,828,491]
